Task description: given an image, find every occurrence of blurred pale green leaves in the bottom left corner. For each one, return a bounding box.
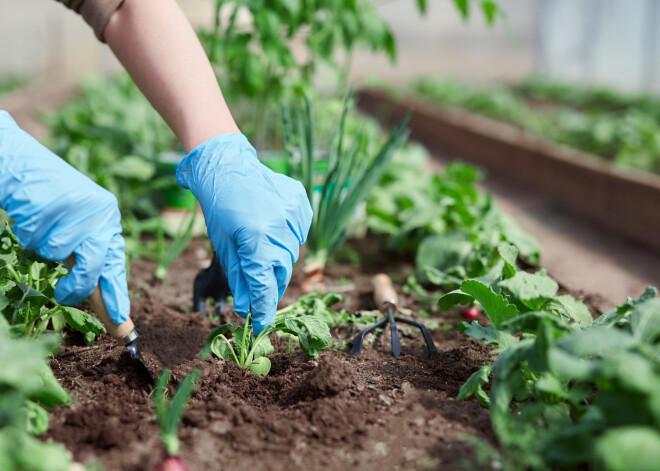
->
[0,322,71,471]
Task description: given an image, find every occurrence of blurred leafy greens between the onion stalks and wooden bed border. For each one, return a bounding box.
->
[367,142,540,289]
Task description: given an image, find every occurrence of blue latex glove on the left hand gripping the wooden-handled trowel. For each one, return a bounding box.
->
[0,111,130,324]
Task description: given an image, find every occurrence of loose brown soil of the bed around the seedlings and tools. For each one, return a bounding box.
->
[45,238,552,471]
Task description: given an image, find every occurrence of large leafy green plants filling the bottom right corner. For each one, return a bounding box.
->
[440,238,660,470]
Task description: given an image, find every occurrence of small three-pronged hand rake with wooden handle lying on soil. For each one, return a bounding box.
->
[353,273,438,357]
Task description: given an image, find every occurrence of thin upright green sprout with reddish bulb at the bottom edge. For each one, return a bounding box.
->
[152,369,200,471]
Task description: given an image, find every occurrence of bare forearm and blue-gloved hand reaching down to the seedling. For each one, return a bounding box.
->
[54,0,312,333]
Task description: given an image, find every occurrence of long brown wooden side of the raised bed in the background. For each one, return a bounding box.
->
[359,89,660,251]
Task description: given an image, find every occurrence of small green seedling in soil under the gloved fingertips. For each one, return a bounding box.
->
[204,314,330,375]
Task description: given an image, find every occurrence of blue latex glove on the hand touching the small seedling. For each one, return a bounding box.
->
[176,134,312,335]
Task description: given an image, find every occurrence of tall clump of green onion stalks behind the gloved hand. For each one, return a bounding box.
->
[282,98,410,269]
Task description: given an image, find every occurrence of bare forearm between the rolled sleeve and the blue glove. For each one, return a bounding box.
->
[104,0,240,152]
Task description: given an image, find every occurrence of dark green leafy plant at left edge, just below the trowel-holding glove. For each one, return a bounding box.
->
[0,221,105,343]
